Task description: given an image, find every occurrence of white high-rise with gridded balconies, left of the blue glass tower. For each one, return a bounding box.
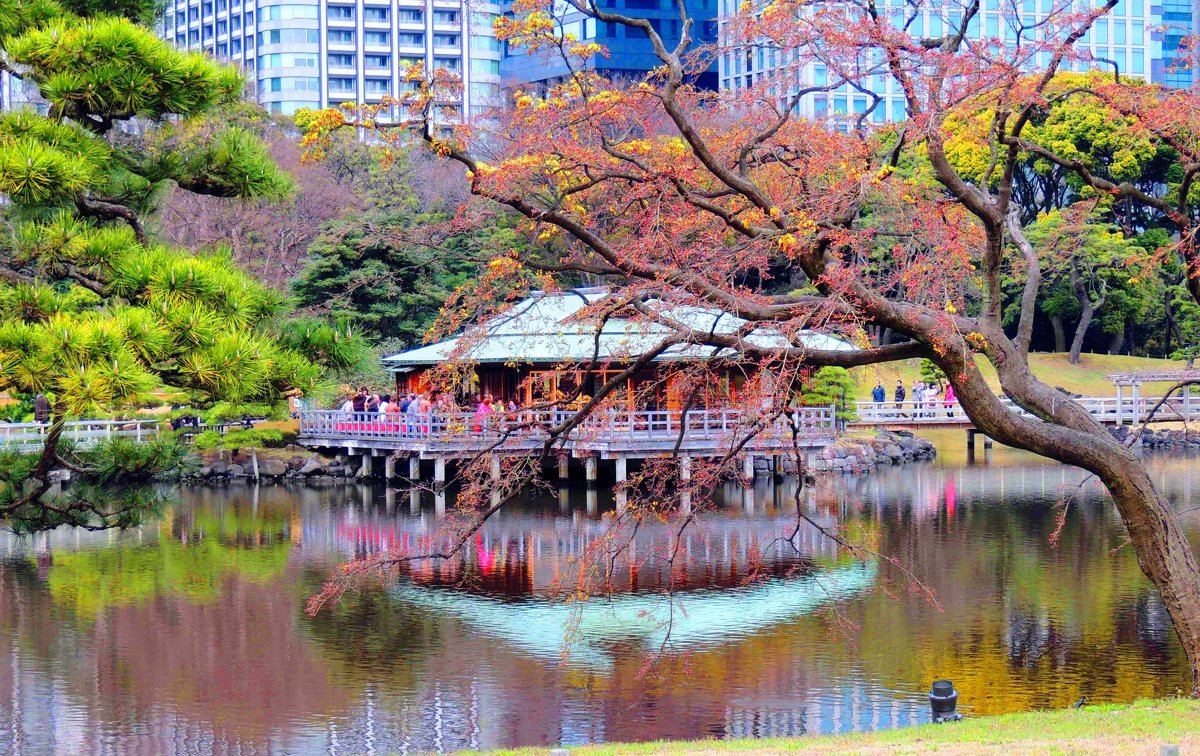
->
[162,0,500,118]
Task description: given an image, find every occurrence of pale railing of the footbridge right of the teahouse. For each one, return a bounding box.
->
[850,394,1200,426]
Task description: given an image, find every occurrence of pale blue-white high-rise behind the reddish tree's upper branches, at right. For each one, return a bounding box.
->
[718,0,1194,122]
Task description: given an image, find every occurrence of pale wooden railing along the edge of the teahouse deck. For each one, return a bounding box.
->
[300,407,835,442]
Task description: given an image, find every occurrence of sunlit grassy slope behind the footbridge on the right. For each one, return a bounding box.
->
[852,352,1187,402]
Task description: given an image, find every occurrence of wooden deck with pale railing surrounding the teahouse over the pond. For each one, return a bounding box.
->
[298,407,836,458]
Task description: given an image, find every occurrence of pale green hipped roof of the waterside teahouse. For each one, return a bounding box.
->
[383,288,856,372]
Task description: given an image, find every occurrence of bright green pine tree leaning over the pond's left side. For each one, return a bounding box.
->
[0,0,348,530]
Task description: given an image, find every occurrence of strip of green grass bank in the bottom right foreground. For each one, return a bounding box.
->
[496,700,1200,756]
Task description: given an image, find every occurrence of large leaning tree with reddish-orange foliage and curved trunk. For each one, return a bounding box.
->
[305,0,1200,695]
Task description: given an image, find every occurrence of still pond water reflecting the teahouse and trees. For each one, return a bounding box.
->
[0,450,1200,754]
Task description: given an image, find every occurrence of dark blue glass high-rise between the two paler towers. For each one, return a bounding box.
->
[500,0,718,89]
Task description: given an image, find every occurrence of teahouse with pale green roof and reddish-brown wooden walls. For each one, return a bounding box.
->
[384,288,854,409]
